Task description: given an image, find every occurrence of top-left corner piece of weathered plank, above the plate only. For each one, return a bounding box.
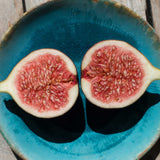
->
[0,0,23,39]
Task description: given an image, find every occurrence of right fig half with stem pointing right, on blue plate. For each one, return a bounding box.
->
[81,40,160,108]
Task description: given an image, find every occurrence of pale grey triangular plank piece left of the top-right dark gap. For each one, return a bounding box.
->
[116,0,146,20]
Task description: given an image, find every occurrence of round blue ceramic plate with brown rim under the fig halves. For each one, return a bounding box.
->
[0,0,160,160]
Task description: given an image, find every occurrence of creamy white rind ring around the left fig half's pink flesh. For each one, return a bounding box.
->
[0,49,79,118]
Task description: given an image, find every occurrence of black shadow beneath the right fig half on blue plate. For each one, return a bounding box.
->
[86,92,160,134]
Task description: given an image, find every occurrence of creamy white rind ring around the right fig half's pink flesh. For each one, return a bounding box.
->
[81,40,155,108]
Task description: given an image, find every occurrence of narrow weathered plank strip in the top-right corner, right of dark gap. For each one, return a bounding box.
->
[150,0,160,36]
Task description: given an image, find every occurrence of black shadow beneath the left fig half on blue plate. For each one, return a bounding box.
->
[5,96,85,143]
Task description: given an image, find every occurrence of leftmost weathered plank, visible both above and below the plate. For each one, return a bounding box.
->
[0,0,23,160]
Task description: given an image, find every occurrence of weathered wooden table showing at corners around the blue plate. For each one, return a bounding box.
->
[0,0,160,160]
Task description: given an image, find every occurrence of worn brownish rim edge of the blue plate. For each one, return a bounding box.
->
[0,0,160,160]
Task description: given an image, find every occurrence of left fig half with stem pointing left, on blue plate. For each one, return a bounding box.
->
[0,49,78,118]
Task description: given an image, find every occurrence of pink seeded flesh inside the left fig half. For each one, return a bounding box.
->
[15,54,77,112]
